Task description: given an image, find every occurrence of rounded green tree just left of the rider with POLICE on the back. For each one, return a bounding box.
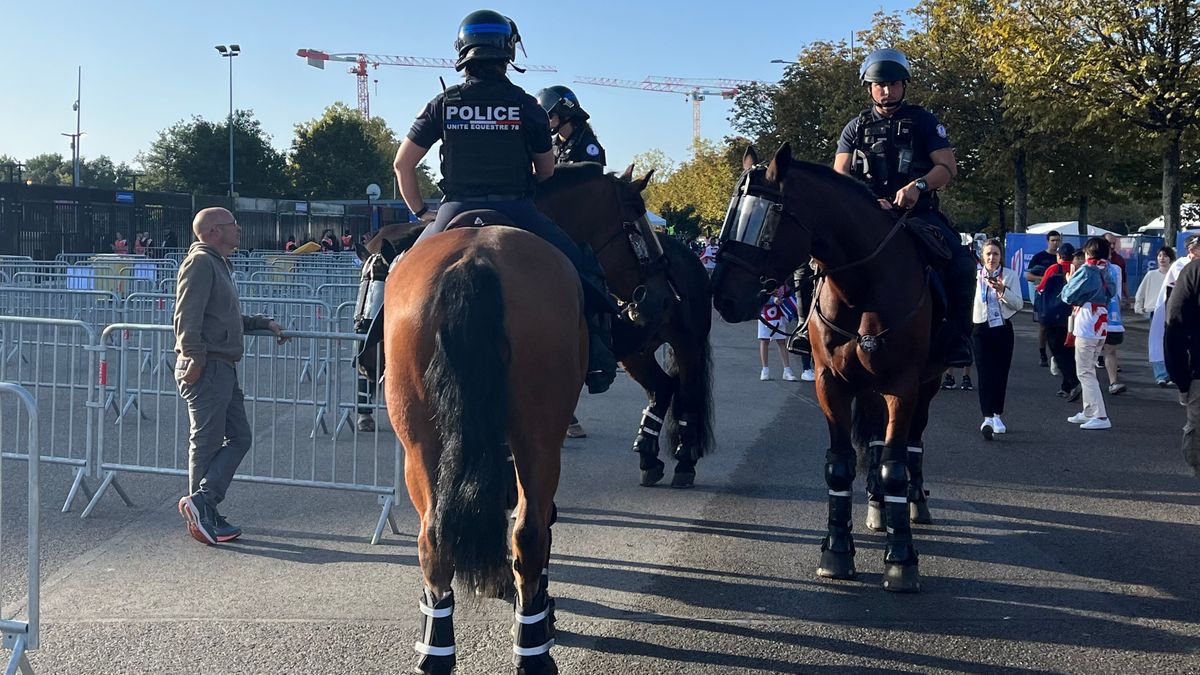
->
[288,102,398,199]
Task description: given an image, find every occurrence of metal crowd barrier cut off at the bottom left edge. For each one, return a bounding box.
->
[0,382,41,675]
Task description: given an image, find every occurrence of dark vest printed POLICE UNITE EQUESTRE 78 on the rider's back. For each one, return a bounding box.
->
[438,80,534,202]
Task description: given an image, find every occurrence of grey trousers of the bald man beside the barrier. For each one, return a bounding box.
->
[176,359,251,504]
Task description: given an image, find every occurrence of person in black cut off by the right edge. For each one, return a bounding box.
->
[1164,254,1200,477]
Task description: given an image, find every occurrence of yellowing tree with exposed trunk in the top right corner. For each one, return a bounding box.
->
[992,0,1200,238]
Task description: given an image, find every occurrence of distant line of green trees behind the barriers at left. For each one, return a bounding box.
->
[0,102,438,199]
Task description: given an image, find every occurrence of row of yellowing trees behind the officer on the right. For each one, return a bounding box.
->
[637,0,1200,240]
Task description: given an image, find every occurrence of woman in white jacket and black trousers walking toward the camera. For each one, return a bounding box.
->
[972,239,1024,441]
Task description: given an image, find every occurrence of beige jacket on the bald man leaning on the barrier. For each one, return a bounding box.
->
[174,241,270,366]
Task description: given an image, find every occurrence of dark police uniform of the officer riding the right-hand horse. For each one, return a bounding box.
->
[838,103,976,366]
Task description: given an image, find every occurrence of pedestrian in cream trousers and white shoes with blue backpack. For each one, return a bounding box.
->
[1062,237,1117,430]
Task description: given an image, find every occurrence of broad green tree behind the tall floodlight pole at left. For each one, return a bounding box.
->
[136,110,289,197]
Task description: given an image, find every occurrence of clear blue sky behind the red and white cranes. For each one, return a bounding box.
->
[0,0,914,176]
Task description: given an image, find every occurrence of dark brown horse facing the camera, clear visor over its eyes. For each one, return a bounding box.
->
[713,144,944,592]
